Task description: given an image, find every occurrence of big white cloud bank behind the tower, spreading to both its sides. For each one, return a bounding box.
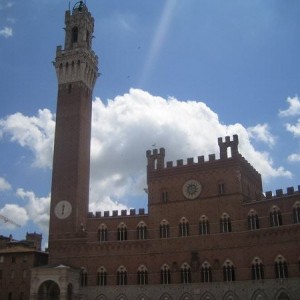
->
[0,89,291,232]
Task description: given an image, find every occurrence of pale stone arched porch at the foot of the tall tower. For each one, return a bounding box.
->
[30,265,81,300]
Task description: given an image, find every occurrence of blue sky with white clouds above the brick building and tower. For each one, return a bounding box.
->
[0,0,300,243]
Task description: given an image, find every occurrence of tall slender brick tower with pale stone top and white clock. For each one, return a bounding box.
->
[49,1,98,246]
